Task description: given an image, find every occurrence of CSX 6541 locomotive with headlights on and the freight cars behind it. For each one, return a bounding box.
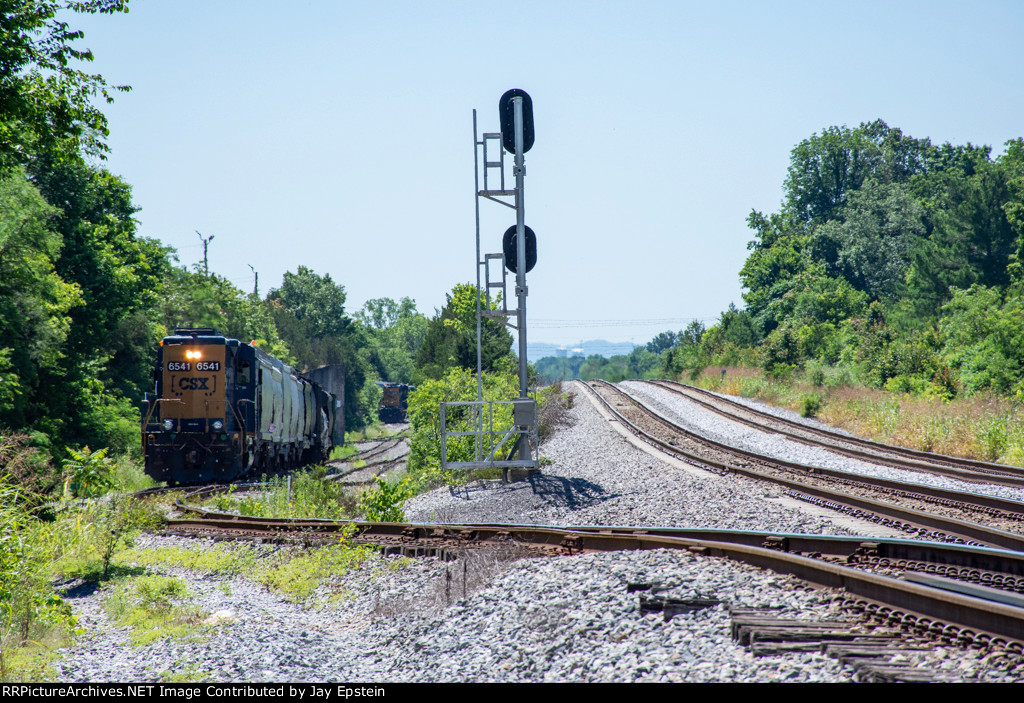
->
[142,328,342,484]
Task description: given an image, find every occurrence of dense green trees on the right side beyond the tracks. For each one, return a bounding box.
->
[666,121,1024,400]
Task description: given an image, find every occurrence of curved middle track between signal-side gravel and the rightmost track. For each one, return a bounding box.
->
[586,382,1024,551]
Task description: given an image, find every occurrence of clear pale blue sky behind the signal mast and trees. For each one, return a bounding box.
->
[71,0,1024,345]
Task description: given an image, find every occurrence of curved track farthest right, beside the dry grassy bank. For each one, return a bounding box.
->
[637,381,1024,488]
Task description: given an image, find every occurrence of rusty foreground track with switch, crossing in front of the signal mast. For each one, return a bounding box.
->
[159,506,1024,656]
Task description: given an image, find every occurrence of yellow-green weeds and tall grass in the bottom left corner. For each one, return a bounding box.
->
[0,435,166,682]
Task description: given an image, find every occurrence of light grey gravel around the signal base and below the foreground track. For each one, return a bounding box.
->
[51,382,1024,683]
